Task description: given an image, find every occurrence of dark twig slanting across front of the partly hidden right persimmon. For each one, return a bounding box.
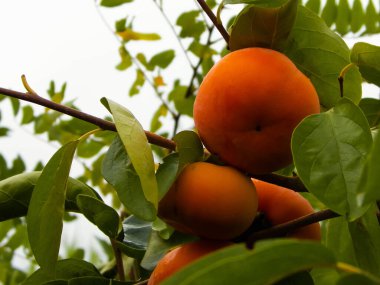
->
[246,207,340,248]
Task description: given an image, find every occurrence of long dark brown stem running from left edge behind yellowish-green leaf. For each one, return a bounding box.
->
[0,87,176,150]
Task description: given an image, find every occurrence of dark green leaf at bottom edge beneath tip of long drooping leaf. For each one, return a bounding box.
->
[22,259,101,285]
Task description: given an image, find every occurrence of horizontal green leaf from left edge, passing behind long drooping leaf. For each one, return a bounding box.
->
[0,171,100,222]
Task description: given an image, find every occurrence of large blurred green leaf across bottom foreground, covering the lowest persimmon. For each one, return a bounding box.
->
[165,239,336,285]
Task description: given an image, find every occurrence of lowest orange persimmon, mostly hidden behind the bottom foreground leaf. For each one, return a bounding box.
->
[148,240,232,285]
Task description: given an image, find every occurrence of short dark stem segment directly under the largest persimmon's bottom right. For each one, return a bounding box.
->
[249,173,308,192]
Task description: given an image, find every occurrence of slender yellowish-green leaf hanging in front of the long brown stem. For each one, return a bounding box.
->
[102,98,158,212]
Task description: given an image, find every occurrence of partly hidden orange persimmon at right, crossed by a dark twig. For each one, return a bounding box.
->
[253,179,321,241]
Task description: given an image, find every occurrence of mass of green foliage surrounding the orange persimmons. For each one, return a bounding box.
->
[0,0,380,285]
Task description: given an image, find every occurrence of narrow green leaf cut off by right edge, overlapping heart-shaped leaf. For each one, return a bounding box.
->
[359,130,380,205]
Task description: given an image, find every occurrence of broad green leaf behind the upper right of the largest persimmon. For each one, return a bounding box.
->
[284,6,362,109]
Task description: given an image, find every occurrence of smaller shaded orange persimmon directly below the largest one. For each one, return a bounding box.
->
[158,162,258,240]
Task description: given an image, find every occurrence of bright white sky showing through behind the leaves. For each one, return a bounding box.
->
[0,0,380,268]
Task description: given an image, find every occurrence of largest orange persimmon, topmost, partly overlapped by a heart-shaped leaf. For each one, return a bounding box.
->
[194,47,320,174]
